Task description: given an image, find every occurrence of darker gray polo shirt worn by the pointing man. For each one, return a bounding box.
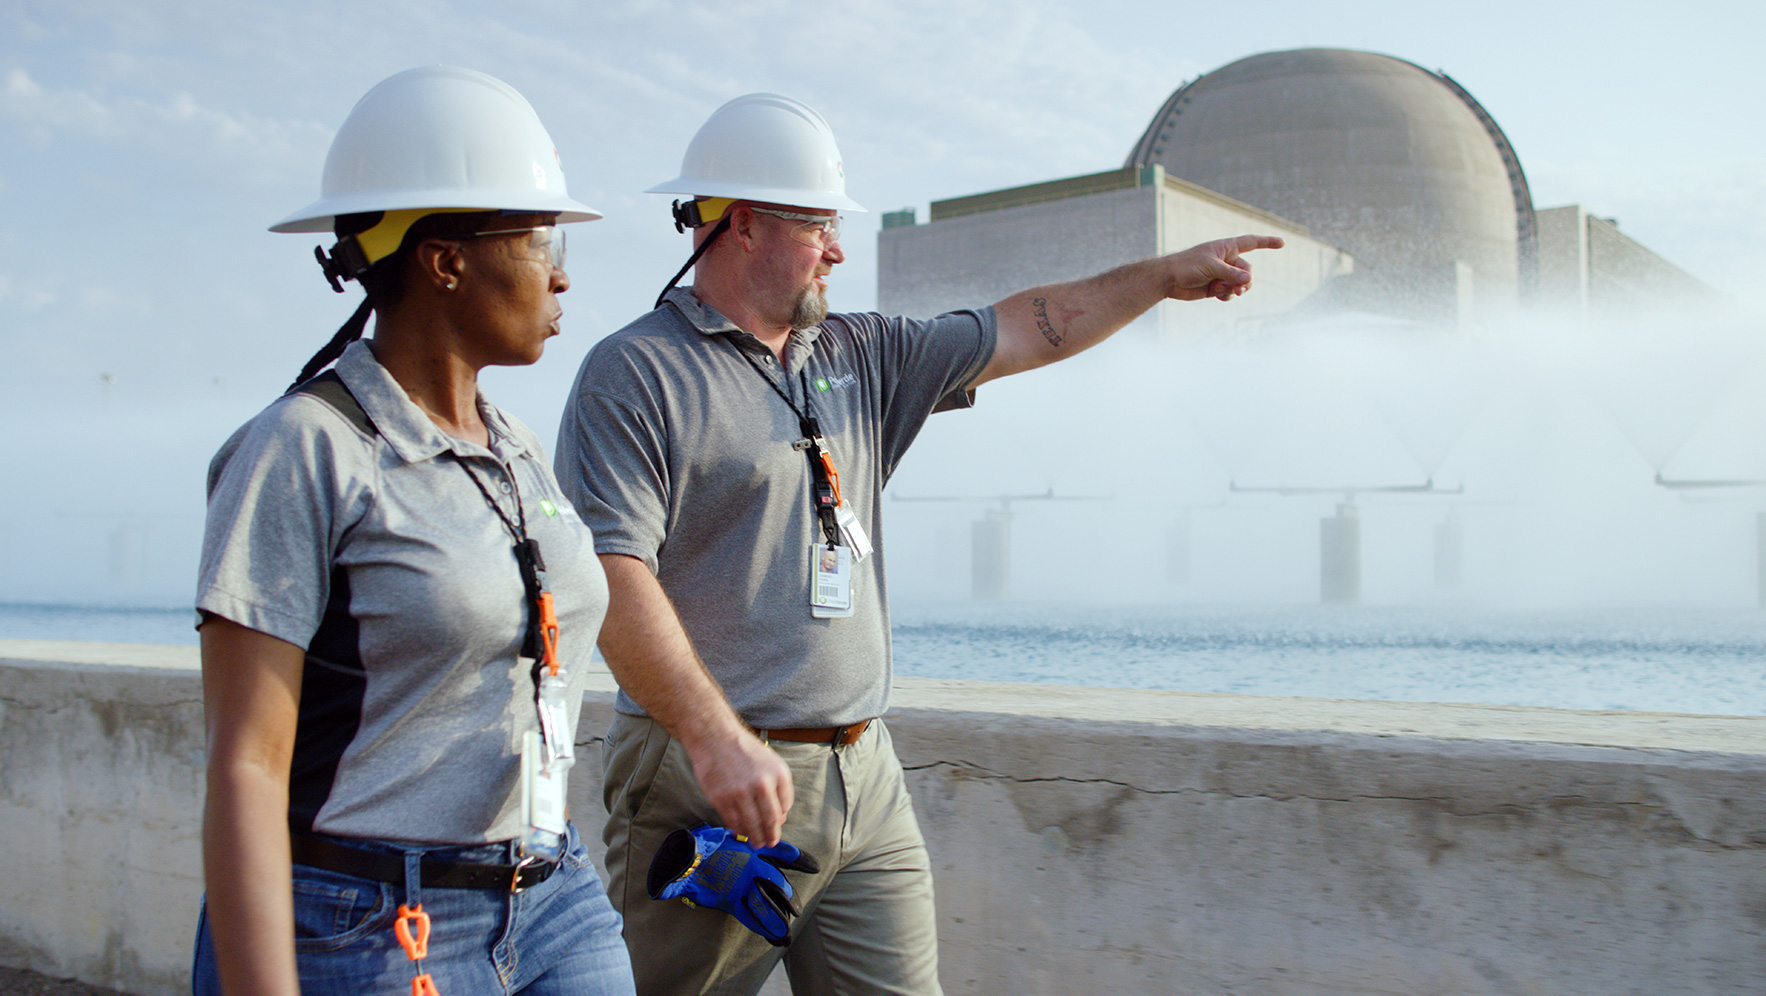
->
[556,290,994,729]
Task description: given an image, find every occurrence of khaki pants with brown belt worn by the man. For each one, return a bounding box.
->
[604,715,941,996]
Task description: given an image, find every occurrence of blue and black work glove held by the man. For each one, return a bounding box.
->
[645,825,821,947]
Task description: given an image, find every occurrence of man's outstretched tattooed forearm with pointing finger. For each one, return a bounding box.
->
[970,235,1282,387]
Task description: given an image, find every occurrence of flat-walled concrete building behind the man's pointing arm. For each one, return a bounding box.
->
[878,166,1355,337]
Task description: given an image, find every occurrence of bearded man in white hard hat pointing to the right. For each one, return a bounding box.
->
[558,94,1280,994]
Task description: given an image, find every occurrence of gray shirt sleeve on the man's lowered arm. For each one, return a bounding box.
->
[553,343,671,572]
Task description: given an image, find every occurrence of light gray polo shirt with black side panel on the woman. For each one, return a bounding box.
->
[196,343,608,844]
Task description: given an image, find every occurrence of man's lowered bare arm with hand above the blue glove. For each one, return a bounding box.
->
[600,553,791,848]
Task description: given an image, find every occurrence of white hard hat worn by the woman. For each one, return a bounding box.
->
[270,65,600,231]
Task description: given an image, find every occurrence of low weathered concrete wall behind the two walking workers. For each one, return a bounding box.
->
[0,641,1766,996]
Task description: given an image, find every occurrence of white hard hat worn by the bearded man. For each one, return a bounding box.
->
[645,94,865,210]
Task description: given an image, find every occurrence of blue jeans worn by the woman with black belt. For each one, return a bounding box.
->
[191,825,634,996]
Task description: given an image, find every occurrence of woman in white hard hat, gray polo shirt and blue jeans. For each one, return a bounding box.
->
[192,67,632,996]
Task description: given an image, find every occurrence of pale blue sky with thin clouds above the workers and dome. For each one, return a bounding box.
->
[0,0,1766,600]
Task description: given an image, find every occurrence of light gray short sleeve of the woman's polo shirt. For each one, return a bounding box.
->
[196,397,373,646]
